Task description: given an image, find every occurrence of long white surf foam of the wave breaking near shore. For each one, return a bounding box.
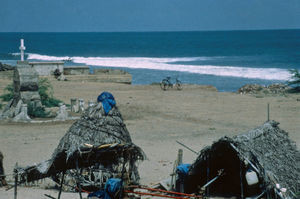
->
[27,53,291,81]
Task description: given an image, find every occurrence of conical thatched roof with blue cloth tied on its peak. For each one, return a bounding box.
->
[19,103,145,182]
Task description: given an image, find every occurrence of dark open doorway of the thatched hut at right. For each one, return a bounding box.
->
[185,142,260,198]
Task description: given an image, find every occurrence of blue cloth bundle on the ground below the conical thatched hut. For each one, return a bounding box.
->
[88,178,122,199]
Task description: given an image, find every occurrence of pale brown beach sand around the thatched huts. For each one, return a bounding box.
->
[0,80,300,199]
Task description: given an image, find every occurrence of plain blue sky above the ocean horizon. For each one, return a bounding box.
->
[0,0,300,32]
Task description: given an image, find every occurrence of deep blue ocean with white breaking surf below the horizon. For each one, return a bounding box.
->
[0,30,300,91]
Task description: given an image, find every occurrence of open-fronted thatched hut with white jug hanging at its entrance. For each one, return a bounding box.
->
[185,121,300,199]
